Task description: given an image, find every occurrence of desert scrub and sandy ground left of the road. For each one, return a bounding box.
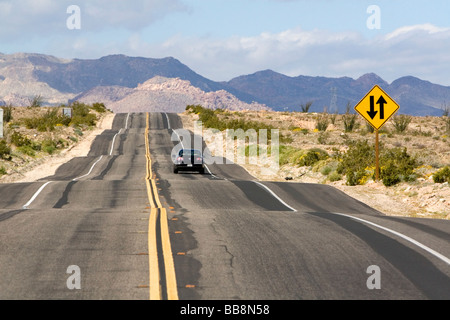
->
[0,101,109,177]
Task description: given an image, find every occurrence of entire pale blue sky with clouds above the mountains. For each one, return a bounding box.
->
[0,0,450,86]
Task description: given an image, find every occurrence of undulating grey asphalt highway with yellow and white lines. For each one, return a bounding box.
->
[0,113,450,300]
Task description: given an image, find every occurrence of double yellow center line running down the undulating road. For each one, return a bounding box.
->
[145,113,178,300]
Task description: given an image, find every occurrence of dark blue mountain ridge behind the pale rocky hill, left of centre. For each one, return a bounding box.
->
[29,55,221,93]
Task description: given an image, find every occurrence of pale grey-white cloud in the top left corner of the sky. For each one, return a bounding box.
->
[0,0,187,42]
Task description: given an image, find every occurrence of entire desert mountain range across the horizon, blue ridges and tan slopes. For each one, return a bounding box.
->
[0,53,450,116]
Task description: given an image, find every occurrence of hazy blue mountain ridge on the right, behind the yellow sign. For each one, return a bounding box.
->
[227,70,450,116]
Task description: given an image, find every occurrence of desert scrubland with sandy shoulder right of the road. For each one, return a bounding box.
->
[181,103,450,219]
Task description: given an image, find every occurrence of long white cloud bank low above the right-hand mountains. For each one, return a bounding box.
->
[140,25,450,85]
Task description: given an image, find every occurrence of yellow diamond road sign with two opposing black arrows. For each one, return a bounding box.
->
[355,86,400,130]
